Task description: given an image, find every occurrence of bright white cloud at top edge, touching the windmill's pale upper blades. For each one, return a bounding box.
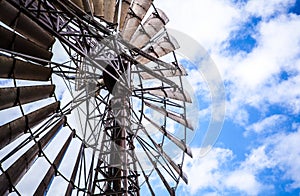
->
[156,0,240,49]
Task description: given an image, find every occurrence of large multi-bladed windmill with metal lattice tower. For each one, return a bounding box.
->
[0,0,193,195]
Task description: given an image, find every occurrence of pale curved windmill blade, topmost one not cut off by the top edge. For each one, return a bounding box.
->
[130,9,169,48]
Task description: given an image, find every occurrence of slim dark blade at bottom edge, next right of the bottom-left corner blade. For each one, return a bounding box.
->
[34,133,73,196]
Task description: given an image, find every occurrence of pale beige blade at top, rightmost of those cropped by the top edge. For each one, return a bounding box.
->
[121,0,153,41]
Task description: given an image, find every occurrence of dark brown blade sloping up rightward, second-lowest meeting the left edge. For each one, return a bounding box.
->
[0,102,59,149]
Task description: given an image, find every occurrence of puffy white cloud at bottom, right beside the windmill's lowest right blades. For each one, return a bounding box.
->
[179,148,270,195]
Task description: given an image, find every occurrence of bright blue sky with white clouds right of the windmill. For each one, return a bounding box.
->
[155,0,300,195]
